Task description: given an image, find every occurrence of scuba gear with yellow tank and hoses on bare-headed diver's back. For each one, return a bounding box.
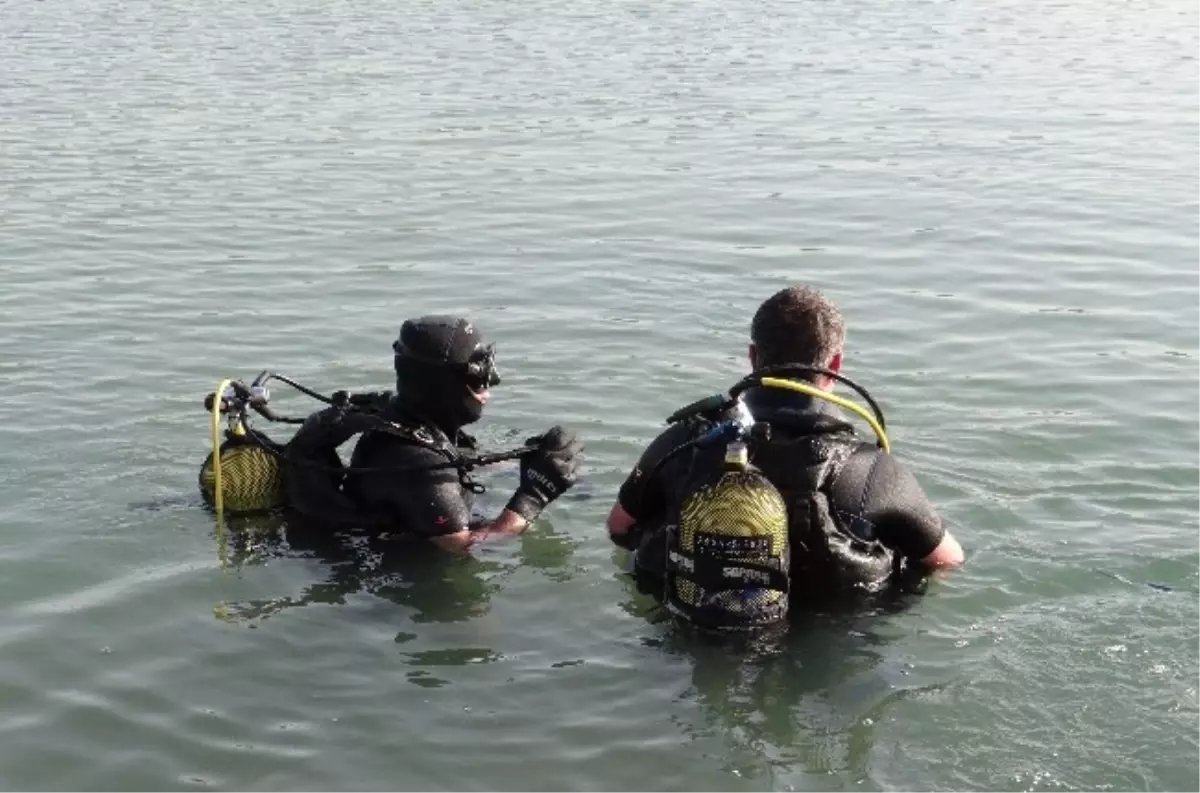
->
[646,364,890,630]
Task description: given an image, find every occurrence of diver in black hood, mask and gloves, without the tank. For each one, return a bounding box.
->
[288,316,582,553]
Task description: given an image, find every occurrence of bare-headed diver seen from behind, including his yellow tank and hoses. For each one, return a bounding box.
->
[607,287,962,632]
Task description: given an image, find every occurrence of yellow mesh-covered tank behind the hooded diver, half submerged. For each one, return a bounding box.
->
[198,429,287,515]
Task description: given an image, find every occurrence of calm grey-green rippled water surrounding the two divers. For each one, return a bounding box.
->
[0,0,1200,793]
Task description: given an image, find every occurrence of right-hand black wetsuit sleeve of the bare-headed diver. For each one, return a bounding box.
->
[829,445,946,559]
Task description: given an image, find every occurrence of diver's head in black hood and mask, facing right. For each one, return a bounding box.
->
[391,314,500,437]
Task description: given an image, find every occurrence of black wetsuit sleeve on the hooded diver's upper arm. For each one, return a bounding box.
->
[355,444,470,537]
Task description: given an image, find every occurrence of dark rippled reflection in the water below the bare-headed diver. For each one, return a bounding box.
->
[624,563,926,791]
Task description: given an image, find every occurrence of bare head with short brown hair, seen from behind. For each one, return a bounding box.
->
[750,287,846,367]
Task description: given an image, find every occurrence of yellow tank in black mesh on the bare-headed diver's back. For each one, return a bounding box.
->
[666,431,791,631]
